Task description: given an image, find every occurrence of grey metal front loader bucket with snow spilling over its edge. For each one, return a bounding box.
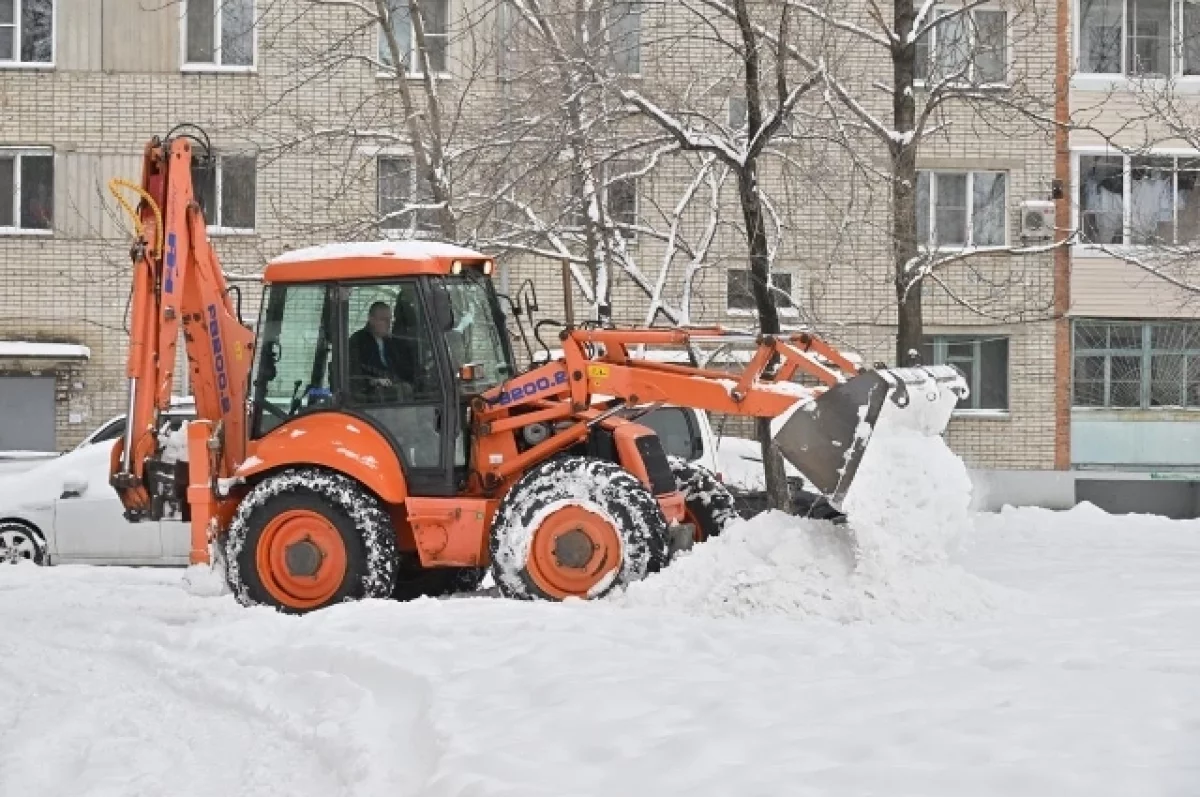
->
[772,365,967,510]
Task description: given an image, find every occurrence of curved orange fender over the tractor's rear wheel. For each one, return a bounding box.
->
[236,412,408,504]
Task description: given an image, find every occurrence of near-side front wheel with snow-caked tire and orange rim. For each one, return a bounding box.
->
[491,456,667,600]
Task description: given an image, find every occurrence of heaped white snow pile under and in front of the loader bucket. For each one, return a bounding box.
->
[612,405,1007,623]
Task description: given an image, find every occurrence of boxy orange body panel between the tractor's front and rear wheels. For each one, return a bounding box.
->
[404,496,499,567]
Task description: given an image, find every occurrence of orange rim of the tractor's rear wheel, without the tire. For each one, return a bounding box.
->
[254,509,346,609]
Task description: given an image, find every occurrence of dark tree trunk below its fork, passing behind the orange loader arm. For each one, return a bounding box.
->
[738,161,791,511]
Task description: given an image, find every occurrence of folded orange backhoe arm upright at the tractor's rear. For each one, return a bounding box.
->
[109,136,253,521]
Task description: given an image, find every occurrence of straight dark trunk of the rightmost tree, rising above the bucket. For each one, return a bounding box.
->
[890,0,924,365]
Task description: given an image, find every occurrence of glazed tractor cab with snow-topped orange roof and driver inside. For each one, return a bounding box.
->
[250,241,516,496]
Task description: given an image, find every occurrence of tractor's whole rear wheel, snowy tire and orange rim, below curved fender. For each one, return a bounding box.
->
[224,467,396,613]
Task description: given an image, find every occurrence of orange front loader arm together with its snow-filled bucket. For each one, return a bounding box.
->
[474,328,967,505]
